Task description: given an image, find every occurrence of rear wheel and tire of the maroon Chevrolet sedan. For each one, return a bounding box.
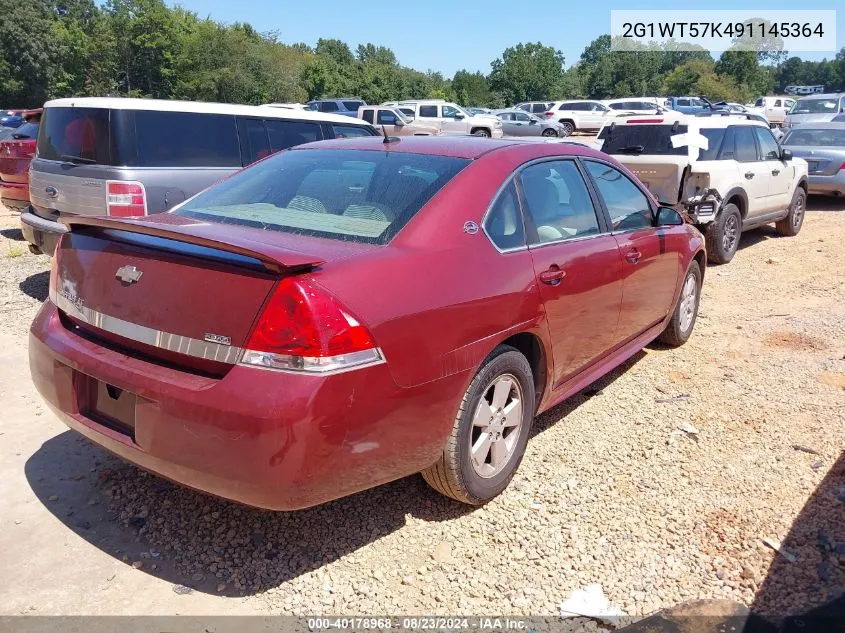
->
[422,345,534,505]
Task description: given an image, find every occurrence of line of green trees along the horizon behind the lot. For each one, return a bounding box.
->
[0,0,845,107]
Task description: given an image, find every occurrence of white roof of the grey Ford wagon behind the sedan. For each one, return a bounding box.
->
[44,97,363,125]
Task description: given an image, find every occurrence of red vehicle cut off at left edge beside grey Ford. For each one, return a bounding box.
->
[0,108,41,211]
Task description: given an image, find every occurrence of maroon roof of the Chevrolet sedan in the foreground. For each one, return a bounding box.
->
[289,136,607,160]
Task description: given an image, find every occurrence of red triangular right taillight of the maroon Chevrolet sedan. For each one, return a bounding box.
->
[241,277,383,374]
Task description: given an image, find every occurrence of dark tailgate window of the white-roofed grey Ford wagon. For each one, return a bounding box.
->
[38,108,112,165]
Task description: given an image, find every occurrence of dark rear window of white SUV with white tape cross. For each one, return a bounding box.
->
[599,123,725,160]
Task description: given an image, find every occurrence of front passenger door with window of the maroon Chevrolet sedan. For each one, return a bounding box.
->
[584,160,688,342]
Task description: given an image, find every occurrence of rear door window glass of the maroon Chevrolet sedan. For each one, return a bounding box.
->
[520,160,599,244]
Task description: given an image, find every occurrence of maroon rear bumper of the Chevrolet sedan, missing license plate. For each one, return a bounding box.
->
[29,300,465,510]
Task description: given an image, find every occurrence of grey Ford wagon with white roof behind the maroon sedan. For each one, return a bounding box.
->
[21,98,378,255]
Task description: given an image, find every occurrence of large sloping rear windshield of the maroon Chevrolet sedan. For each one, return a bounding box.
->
[173,149,469,244]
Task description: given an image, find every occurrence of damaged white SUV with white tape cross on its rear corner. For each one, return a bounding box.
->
[597,112,807,264]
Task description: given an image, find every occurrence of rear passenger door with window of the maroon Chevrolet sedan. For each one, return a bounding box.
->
[519,160,622,387]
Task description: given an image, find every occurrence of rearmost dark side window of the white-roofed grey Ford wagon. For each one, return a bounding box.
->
[135,110,241,167]
